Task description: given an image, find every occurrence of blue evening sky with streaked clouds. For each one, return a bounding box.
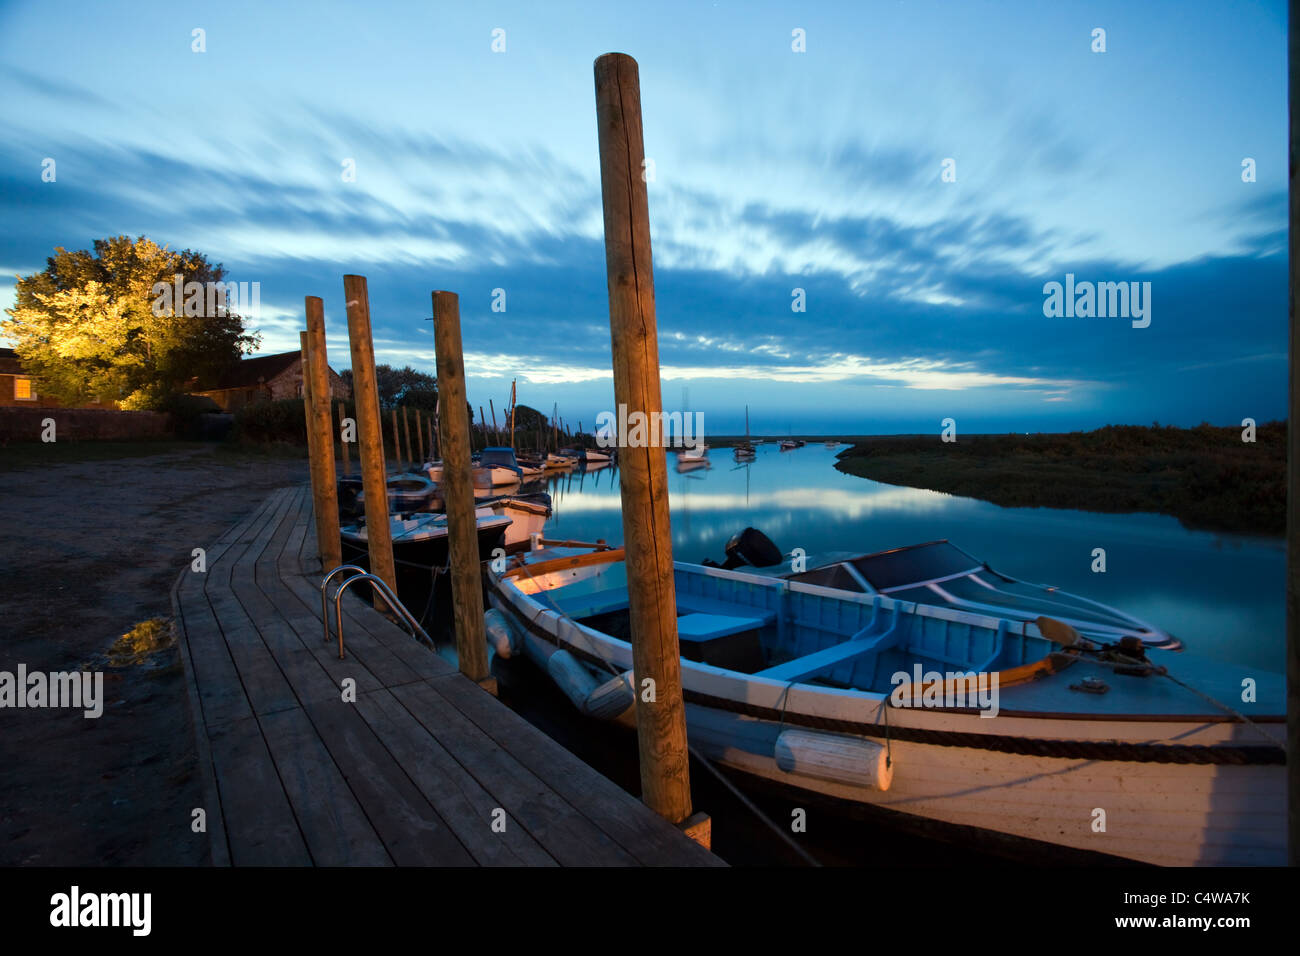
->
[0,0,1287,433]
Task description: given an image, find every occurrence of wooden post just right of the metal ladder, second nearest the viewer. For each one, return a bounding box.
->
[433,291,497,693]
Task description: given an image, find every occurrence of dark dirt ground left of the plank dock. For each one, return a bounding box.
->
[0,442,307,866]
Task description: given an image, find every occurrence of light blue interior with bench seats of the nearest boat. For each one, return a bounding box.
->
[545,562,1054,692]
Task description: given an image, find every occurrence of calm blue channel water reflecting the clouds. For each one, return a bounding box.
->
[525,444,1286,671]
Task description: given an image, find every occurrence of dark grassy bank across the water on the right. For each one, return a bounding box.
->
[836,421,1287,535]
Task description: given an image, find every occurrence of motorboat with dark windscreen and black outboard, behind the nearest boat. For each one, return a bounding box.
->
[705,528,1183,650]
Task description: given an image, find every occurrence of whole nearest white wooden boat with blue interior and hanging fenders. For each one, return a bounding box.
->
[488,548,1286,866]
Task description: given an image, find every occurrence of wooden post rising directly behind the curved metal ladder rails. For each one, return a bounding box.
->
[343,276,398,594]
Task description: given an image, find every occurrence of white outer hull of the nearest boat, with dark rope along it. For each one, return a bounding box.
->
[489,561,1286,866]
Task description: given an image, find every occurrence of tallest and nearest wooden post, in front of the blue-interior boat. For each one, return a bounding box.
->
[595,53,710,845]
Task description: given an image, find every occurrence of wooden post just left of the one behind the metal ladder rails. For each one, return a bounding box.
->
[303,295,343,571]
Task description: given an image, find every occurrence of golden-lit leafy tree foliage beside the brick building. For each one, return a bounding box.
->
[0,235,259,408]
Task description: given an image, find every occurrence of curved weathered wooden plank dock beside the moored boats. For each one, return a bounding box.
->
[172,488,722,866]
